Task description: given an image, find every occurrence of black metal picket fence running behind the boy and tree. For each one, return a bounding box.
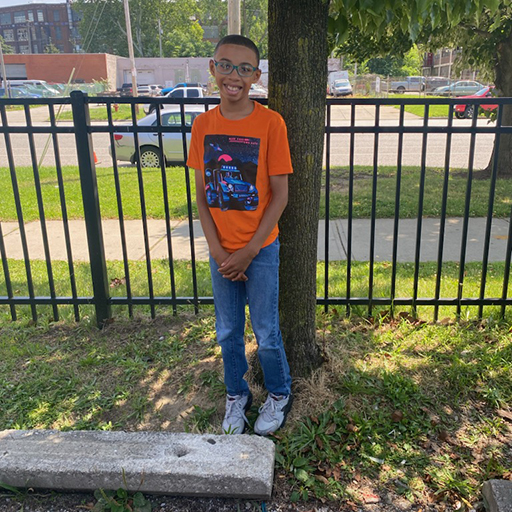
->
[0,92,512,322]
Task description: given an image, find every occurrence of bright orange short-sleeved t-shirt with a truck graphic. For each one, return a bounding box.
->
[187,102,293,252]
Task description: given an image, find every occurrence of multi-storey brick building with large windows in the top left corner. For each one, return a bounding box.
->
[0,0,80,54]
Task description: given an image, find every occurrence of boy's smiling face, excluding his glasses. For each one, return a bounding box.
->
[210,44,261,106]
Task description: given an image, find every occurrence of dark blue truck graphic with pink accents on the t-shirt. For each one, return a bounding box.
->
[204,135,260,211]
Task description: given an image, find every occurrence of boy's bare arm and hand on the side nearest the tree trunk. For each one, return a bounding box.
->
[217,174,288,281]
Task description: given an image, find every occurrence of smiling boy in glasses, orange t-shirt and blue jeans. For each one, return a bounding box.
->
[187,35,293,435]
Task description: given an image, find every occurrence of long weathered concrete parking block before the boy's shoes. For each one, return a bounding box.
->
[0,430,275,499]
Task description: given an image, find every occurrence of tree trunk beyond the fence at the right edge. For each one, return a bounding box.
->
[487,33,512,177]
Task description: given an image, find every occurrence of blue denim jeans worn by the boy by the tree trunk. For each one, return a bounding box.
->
[210,239,291,395]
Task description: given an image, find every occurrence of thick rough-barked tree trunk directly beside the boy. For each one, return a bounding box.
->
[268,0,329,377]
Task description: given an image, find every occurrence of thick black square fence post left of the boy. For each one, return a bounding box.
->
[71,91,112,327]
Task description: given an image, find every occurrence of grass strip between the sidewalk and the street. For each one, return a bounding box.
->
[0,166,512,221]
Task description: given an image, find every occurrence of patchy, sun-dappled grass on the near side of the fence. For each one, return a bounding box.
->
[0,310,512,511]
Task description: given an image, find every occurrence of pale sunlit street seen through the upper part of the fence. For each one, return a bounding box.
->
[0,105,494,170]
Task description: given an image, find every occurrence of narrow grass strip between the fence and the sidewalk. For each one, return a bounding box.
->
[0,260,511,322]
